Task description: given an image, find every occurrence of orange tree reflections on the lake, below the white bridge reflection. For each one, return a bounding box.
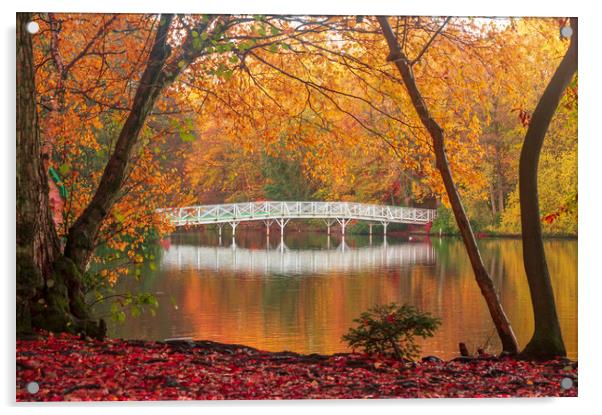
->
[105,235,577,357]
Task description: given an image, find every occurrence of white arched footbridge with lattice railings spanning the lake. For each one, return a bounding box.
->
[159,202,436,235]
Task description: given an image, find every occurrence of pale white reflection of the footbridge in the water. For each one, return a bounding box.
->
[162,242,435,274]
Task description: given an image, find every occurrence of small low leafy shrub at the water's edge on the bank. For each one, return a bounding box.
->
[343,303,441,360]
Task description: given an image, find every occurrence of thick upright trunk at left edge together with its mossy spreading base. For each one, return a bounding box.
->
[16,13,105,337]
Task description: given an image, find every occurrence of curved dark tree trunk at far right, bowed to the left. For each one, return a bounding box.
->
[519,18,577,359]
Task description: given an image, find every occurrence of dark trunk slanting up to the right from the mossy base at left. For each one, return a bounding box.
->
[65,15,175,272]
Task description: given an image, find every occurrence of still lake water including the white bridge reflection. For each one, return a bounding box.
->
[102,230,577,358]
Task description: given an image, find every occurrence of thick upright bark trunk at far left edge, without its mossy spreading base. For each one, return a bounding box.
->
[16,13,59,332]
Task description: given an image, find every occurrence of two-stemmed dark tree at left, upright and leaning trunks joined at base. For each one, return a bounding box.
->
[17,14,217,338]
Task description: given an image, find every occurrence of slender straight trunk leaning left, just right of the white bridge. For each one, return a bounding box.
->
[378,16,518,354]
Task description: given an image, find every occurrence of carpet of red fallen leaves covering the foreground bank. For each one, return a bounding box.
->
[17,335,577,401]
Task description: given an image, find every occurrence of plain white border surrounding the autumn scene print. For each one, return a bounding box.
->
[0,0,602,415]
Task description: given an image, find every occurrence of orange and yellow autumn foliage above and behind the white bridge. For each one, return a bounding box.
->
[28,13,577,292]
